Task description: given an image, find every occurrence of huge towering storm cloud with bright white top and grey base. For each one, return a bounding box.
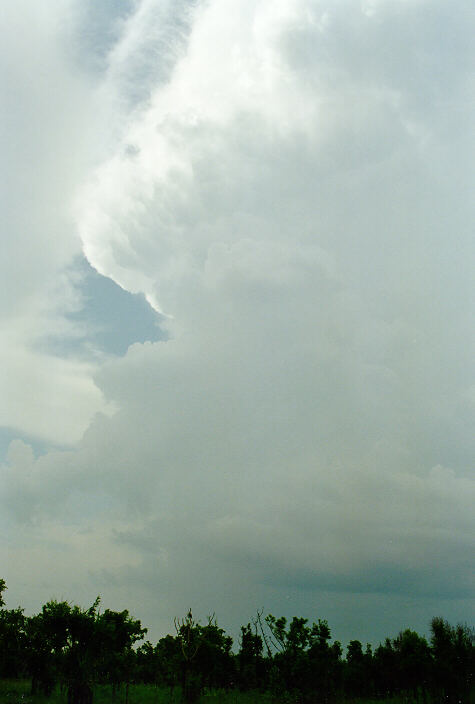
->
[3,0,473,639]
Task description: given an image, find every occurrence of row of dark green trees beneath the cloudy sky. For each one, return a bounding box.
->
[0,579,474,704]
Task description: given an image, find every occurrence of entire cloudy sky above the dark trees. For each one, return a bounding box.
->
[0,0,475,644]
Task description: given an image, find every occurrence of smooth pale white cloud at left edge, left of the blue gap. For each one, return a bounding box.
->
[0,2,118,444]
